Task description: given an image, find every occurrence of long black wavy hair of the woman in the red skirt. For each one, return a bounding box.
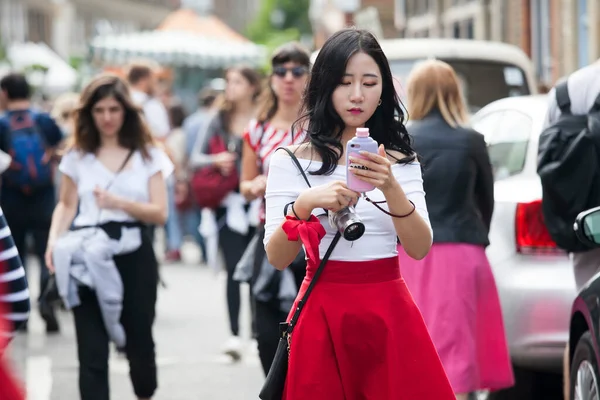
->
[294,29,416,175]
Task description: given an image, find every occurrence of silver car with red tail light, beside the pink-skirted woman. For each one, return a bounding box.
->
[472,95,576,400]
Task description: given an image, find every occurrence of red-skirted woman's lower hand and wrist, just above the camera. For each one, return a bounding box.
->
[294,181,360,218]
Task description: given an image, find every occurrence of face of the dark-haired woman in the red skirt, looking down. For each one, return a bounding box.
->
[331,53,383,128]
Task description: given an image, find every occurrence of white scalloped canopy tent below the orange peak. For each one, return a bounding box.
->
[90,30,265,68]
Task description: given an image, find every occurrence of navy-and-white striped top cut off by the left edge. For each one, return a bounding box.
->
[0,208,30,338]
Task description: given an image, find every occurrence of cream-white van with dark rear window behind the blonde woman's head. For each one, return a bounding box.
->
[312,39,537,113]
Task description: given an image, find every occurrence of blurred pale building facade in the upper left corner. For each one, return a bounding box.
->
[0,0,180,59]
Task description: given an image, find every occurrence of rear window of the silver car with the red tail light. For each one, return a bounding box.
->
[473,110,533,180]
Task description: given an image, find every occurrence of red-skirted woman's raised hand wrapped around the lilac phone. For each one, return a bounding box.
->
[348,145,398,192]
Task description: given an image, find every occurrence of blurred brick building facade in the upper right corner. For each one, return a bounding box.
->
[394,0,600,87]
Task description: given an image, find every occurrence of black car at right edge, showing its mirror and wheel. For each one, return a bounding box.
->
[569,207,600,400]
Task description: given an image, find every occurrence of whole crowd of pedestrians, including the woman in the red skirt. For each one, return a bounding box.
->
[0,29,514,400]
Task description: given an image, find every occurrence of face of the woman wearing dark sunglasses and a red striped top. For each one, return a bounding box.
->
[271,62,308,105]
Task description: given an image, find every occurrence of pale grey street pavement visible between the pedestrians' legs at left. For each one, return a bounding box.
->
[10,244,263,400]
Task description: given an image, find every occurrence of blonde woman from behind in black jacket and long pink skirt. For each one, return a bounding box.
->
[398,60,514,400]
